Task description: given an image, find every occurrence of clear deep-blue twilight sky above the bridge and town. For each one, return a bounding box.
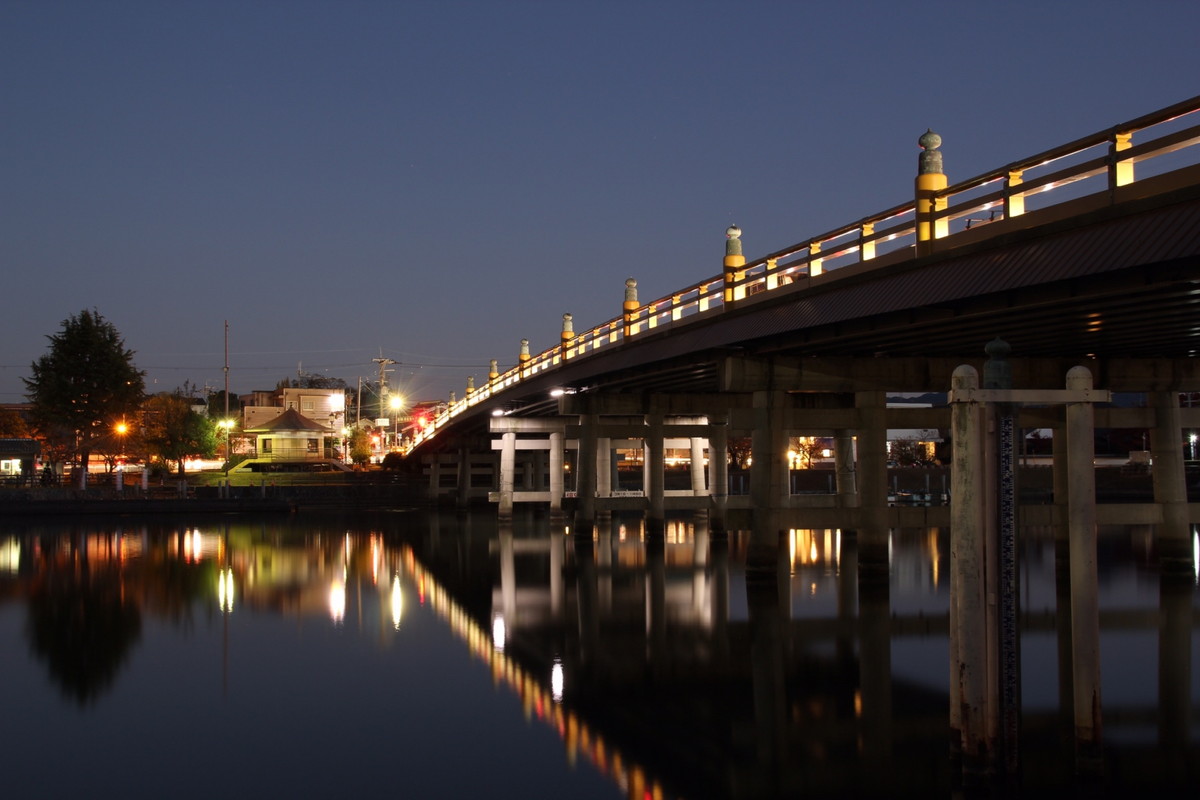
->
[0,0,1200,403]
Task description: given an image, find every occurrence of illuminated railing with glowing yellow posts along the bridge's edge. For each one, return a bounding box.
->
[415,96,1200,444]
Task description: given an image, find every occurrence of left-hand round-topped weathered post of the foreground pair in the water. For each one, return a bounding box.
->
[950,365,995,781]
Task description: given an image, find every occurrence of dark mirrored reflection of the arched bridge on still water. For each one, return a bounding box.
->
[427,513,1200,798]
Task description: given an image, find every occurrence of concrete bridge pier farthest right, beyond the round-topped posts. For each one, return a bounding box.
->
[1150,391,1193,572]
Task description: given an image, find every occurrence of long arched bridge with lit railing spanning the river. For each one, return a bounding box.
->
[412,97,1200,532]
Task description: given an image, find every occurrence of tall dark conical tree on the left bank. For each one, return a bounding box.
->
[22,309,145,486]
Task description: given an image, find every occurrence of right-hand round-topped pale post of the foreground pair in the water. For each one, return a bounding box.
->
[1067,367,1103,775]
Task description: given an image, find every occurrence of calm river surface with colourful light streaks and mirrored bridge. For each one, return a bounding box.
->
[0,512,1200,799]
